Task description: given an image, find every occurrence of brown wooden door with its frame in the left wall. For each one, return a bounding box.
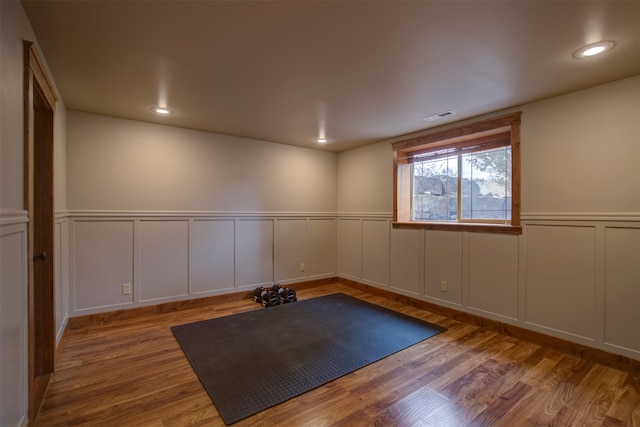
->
[23,40,58,424]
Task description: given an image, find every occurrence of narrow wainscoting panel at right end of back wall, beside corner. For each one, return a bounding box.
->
[305,218,336,278]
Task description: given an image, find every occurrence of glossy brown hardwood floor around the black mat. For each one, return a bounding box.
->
[35,284,640,427]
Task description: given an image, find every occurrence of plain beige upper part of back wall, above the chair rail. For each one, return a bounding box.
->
[67,111,337,213]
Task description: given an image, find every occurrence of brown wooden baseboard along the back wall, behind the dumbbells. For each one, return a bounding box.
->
[67,277,337,329]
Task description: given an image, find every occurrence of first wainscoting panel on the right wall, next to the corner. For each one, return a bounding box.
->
[338,218,362,279]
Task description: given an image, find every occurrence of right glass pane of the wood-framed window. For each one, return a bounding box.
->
[460,147,511,221]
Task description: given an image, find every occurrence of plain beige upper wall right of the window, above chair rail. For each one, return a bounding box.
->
[521,76,640,216]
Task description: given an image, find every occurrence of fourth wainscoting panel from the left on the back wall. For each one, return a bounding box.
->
[236,219,274,288]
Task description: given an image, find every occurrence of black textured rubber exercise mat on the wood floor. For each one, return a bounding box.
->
[171,294,446,424]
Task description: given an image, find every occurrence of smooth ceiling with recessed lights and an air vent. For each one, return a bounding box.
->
[22,0,640,151]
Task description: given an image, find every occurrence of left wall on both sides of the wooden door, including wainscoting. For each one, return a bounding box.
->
[0,0,68,426]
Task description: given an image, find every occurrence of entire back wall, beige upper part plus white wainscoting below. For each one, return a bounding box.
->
[67,111,337,316]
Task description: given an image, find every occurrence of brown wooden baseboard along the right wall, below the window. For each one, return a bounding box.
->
[336,277,640,372]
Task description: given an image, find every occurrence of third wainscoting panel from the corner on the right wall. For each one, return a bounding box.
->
[389,228,424,296]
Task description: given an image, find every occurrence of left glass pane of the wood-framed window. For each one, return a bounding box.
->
[411,156,458,221]
